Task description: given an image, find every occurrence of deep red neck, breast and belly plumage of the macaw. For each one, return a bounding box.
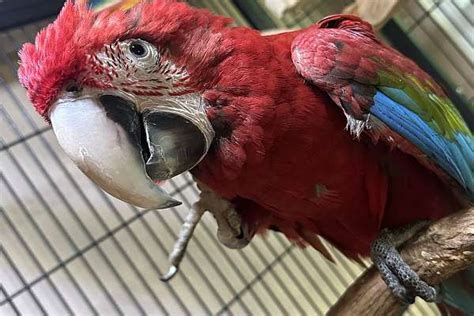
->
[193,26,459,256]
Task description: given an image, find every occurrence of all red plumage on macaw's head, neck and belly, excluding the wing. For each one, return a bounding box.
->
[19,1,458,256]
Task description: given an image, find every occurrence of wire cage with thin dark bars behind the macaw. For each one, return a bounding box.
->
[0,0,474,315]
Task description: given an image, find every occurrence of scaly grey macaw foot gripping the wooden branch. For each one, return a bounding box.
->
[371,222,438,304]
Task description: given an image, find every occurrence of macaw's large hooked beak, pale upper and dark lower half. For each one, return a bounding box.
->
[49,93,212,209]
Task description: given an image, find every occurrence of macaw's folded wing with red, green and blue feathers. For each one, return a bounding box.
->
[292,15,474,198]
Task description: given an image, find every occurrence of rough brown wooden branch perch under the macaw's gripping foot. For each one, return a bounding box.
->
[327,208,474,316]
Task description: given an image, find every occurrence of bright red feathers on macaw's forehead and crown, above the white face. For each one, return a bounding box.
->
[18,0,230,117]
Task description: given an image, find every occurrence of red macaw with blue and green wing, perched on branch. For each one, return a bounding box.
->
[18,0,474,312]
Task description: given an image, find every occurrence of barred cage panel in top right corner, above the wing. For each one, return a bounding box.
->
[395,0,474,104]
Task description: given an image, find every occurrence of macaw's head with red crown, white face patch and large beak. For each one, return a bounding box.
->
[18,0,230,208]
